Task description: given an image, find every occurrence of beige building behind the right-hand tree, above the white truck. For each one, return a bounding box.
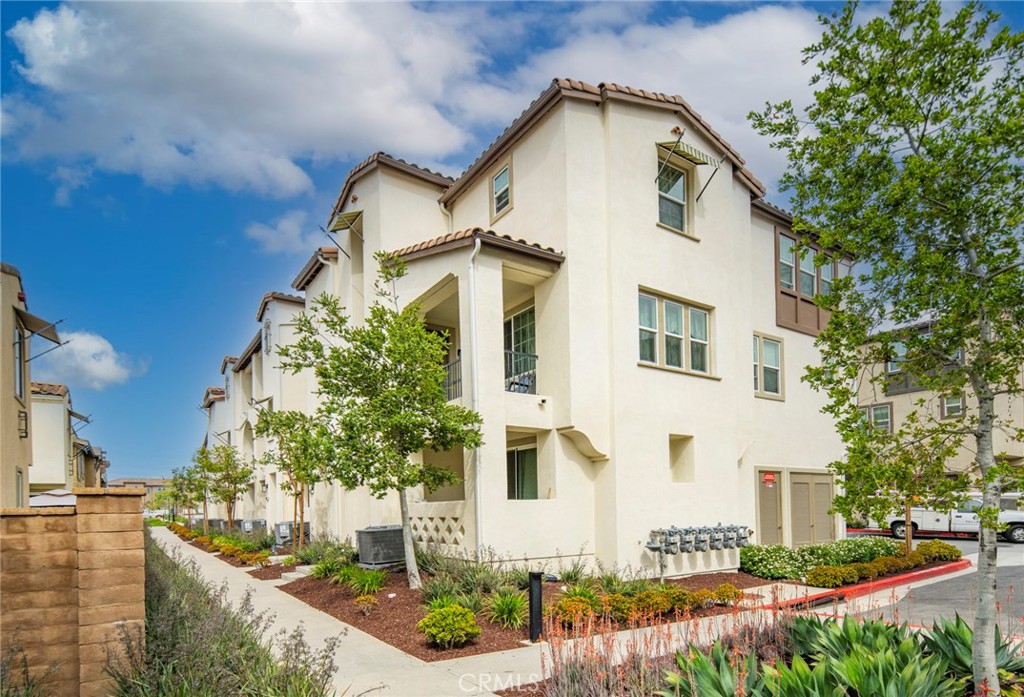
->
[857,325,1024,472]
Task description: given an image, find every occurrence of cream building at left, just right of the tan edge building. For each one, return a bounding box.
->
[29,383,92,493]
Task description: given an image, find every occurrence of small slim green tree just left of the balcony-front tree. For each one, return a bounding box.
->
[256,409,330,548]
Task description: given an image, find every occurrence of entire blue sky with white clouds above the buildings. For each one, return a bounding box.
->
[0,2,1024,477]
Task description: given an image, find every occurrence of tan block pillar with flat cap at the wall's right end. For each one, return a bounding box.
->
[75,489,145,697]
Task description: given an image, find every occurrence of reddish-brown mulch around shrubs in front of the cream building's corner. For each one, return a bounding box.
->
[280,572,765,659]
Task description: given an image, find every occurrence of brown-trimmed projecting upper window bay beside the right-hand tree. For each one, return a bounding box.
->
[775,227,850,336]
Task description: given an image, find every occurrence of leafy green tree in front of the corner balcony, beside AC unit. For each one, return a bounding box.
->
[280,253,481,589]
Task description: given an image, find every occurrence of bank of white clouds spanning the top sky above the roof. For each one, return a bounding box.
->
[0,2,820,198]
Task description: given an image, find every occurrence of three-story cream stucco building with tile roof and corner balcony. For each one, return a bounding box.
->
[199,80,847,574]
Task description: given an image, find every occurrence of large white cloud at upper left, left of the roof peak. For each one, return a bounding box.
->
[3,3,482,198]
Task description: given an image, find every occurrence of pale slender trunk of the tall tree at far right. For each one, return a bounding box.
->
[973,378,1001,697]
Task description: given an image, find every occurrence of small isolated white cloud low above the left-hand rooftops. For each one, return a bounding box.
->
[33,332,148,390]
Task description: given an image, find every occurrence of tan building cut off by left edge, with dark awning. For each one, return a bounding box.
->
[0,262,60,508]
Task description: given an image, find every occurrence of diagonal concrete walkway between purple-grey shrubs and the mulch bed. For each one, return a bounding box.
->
[150,527,499,697]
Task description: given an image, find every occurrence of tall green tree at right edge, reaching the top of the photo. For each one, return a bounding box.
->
[751,0,1024,694]
